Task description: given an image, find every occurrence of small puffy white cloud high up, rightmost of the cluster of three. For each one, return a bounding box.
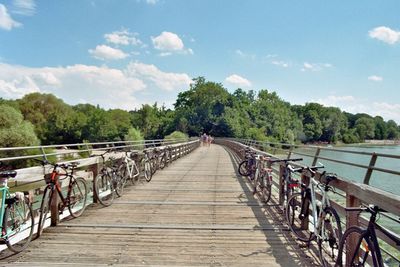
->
[151,32,193,56]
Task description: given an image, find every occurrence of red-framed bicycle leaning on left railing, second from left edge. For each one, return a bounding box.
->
[35,159,87,238]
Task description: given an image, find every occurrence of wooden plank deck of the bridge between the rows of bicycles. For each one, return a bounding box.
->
[0,145,319,266]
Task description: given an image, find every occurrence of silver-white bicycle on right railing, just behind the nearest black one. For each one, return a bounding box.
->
[286,169,342,266]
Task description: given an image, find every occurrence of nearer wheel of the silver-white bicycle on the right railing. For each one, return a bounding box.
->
[318,207,342,267]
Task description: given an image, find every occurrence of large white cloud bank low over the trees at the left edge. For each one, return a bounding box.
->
[0,63,146,110]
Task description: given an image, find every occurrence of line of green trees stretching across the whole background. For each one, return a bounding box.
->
[0,77,400,147]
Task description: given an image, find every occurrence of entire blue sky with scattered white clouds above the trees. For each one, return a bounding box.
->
[0,0,400,124]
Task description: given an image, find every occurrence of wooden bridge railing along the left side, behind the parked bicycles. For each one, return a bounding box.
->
[0,139,199,250]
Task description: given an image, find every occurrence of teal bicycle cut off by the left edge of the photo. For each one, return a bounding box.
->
[0,171,35,253]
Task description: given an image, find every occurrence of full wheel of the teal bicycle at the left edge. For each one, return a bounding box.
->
[3,198,35,253]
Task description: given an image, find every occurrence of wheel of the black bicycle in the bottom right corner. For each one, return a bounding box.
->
[336,226,376,266]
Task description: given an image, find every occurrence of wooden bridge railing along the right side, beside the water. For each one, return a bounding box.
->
[216,139,400,265]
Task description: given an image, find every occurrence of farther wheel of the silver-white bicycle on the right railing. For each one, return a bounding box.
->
[286,193,312,242]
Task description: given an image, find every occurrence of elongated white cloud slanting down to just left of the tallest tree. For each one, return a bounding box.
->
[126,62,192,91]
